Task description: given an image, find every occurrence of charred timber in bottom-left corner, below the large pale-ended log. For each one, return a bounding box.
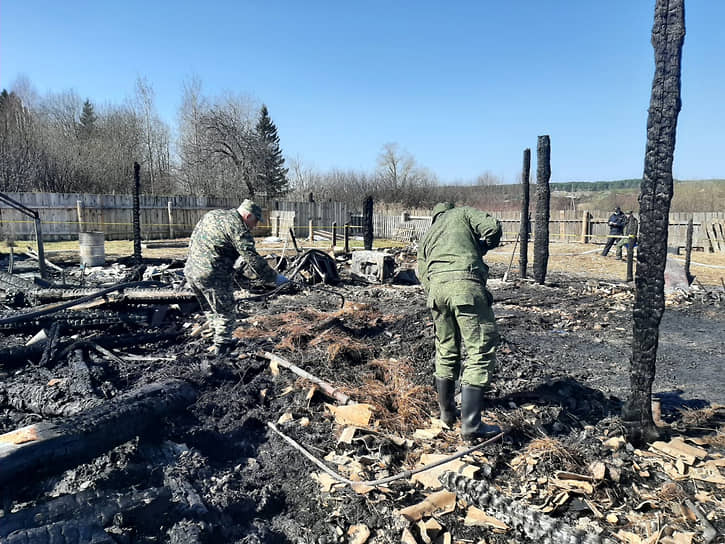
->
[0,487,171,543]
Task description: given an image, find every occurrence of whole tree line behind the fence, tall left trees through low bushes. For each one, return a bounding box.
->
[0,78,501,207]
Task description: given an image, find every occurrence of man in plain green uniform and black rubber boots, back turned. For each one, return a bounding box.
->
[418,202,501,440]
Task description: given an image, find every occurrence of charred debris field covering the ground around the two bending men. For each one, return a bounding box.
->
[0,249,725,544]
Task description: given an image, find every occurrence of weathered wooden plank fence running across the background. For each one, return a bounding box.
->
[0,193,725,251]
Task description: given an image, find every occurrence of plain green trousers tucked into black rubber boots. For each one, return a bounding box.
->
[427,279,498,387]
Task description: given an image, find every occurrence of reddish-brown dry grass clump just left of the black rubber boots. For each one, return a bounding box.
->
[351,359,435,434]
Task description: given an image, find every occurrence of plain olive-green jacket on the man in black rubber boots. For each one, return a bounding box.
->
[418,206,501,291]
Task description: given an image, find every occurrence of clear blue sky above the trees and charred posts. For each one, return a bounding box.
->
[0,0,725,183]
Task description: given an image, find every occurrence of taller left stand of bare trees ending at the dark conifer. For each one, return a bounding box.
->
[0,79,290,198]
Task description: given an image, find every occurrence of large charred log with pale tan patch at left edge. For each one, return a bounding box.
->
[0,380,196,484]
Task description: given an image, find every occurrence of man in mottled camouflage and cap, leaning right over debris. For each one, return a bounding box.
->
[184,199,287,354]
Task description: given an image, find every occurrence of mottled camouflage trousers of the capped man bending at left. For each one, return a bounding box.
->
[186,277,234,345]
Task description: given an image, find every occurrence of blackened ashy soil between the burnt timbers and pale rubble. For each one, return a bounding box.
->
[0,260,725,543]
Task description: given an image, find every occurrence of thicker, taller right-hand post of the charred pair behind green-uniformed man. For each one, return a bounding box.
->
[534,135,551,285]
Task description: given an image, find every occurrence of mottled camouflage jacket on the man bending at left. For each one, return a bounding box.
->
[184,210,277,282]
